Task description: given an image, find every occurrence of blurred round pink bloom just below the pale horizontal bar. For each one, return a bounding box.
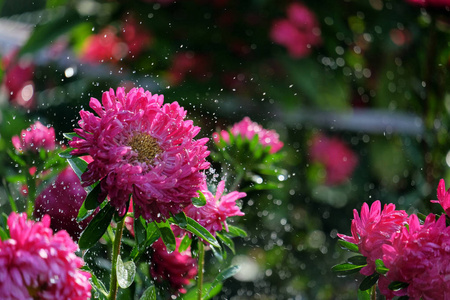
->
[309,134,358,185]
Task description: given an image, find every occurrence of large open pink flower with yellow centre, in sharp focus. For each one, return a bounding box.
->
[69,88,209,221]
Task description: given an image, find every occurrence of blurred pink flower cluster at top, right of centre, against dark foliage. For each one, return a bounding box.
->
[270,2,322,58]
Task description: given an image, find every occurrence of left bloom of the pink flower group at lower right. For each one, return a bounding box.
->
[338,200,408,275]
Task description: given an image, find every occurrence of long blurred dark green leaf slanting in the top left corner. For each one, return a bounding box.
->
[19,9,86,56]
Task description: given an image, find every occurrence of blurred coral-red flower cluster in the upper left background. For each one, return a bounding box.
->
[81,18,152,64]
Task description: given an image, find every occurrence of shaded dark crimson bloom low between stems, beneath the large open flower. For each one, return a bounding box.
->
[150,238,197,295]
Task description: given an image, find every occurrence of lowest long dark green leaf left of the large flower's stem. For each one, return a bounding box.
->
[78,203,114,250]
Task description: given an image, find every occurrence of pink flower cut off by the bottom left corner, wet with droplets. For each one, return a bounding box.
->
[0,213,91,300]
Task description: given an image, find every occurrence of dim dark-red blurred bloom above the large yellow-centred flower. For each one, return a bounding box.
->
[168,52,211,85]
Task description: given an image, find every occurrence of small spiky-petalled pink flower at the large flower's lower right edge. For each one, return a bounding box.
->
[184,181,247,236]
